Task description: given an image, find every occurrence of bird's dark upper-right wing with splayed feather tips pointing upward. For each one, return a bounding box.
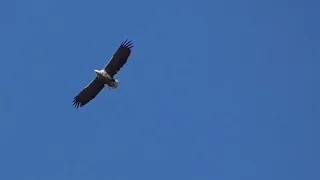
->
[104,40,134,77]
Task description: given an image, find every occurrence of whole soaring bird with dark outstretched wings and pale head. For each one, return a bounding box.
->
[72,40,133,108]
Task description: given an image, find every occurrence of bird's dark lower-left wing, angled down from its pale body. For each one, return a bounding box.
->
[72,78,104,108]
